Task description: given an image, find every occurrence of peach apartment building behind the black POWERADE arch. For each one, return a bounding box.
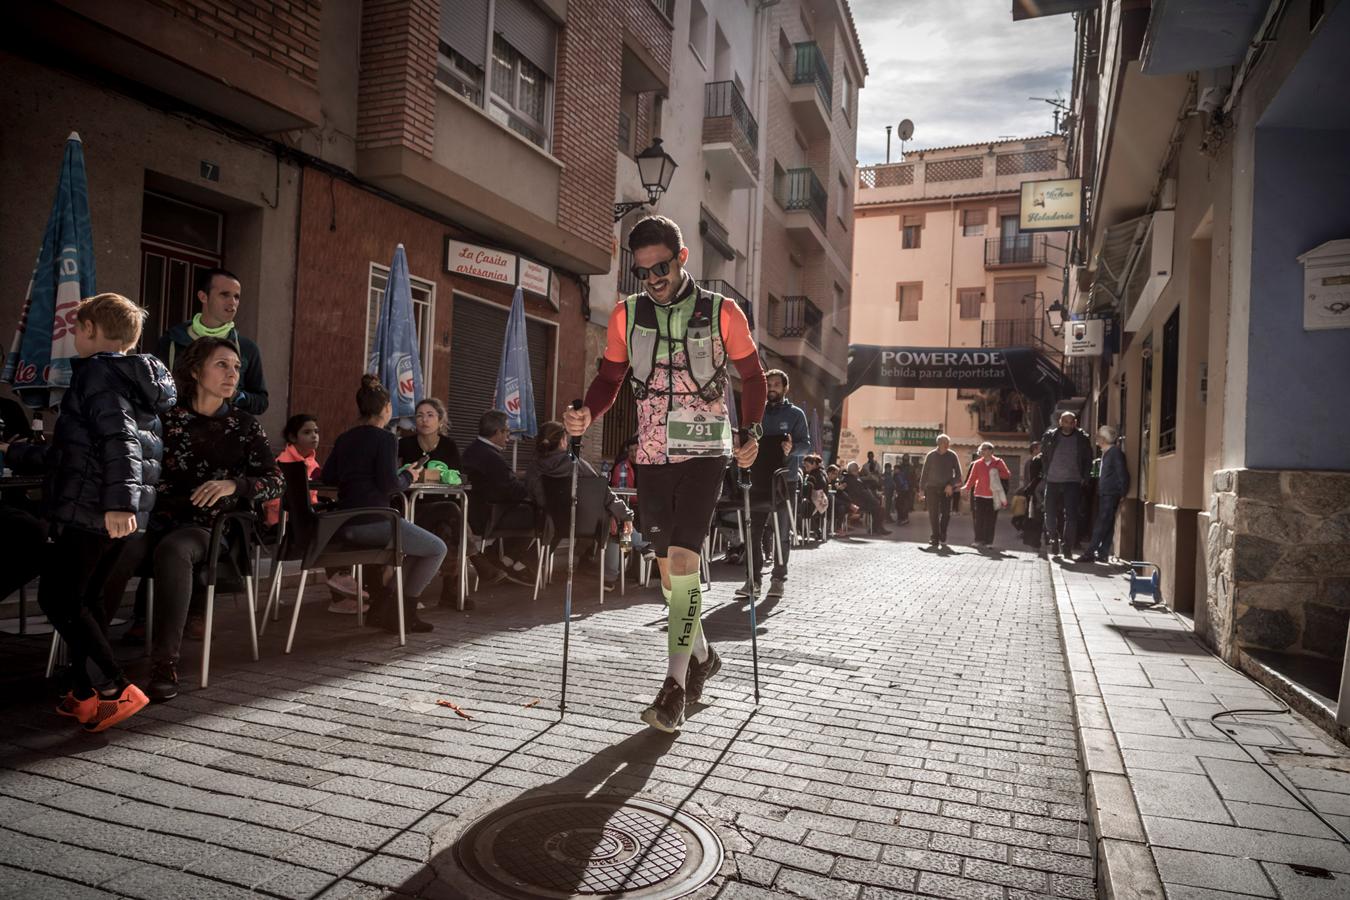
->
[840,135,1069,482]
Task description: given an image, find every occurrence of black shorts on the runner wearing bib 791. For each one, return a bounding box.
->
[635,456,726,557]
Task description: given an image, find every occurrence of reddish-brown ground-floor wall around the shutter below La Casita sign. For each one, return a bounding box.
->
[288,169,593,457]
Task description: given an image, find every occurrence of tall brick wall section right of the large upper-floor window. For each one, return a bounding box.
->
[554,0,623,246]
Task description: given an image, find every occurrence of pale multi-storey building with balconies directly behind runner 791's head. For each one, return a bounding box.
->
[587,0,865,453]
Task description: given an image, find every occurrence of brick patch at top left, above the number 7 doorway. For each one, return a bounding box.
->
[149,0,323,86]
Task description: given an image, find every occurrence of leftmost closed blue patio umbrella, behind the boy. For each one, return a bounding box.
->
[0,132,99,407]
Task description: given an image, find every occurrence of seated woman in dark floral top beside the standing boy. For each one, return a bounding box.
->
[149,337,282,702]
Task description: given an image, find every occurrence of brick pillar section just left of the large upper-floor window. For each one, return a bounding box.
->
[356,0,440,157]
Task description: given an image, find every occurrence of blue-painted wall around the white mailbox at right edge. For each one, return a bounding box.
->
[1229,123,1350,471]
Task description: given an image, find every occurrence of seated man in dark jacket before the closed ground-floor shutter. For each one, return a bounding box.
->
[460,409,535,587]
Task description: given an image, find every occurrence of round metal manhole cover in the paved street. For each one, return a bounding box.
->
[454,796,722,900]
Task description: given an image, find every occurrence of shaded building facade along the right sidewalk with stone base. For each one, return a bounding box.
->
[1027,0,1350,738]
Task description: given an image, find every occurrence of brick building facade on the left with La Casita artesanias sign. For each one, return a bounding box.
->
[0,0,656,461]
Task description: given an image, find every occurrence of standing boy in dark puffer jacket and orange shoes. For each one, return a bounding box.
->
[38,294,177,731]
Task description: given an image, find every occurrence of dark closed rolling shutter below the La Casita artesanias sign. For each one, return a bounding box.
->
[444,294,554,470]
